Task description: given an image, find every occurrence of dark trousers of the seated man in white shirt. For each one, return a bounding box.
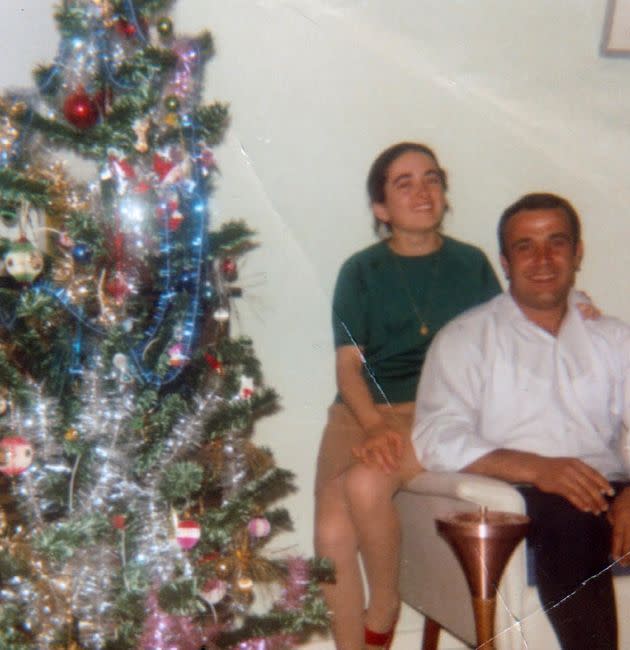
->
[518,484,627,650]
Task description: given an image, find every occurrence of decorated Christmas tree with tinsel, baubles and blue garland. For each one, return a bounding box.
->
[0,0,330,650]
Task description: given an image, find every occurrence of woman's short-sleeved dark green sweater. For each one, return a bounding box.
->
[333,237,501,403]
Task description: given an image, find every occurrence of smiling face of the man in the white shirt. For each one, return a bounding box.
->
[501,208,582,312]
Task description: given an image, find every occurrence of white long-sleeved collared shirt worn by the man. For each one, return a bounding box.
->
[413,293,630,479]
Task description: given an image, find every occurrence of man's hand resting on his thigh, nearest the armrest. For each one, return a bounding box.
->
[532,456,616,512]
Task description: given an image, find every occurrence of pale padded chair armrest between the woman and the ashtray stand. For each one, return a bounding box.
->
[402,472,525,514]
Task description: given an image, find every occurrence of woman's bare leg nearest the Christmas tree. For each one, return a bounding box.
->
[315,474,365,650]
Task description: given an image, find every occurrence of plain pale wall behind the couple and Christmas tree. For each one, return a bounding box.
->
[0,0,630,647]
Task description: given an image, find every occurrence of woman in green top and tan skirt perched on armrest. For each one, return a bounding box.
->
[315,142,500,650]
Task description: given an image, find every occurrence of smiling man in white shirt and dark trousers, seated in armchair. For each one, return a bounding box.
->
[413,194,630,650]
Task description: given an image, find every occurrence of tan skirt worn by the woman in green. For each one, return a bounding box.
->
[315,402,415,492]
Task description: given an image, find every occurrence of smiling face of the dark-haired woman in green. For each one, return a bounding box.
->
[372,151,446,235]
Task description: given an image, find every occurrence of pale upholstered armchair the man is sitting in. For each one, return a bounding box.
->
[396,472,630,650]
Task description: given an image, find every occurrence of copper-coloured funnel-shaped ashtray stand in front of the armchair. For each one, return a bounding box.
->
[436,508,530,650]
